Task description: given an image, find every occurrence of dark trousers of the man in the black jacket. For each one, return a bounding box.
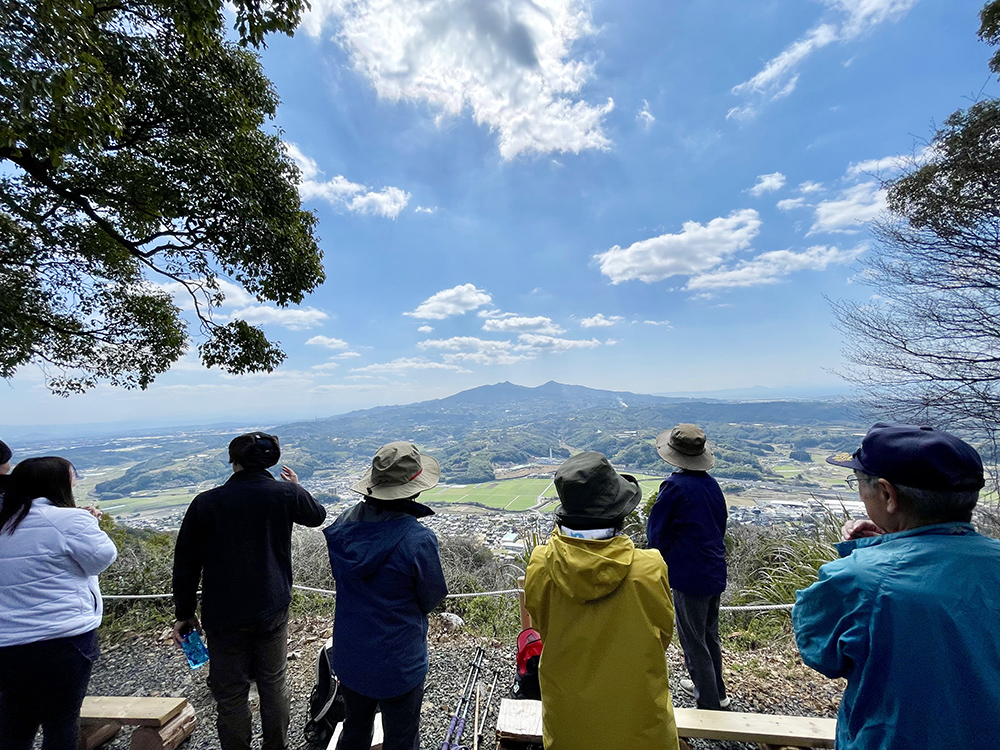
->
[208,609,291,750]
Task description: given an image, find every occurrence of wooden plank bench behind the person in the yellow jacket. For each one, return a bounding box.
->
[497,698,837,748]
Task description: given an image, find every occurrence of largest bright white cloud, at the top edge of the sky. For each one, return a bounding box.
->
[302,0,614,159]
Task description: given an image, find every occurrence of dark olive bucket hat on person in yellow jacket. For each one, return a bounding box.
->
[555,451,642,531]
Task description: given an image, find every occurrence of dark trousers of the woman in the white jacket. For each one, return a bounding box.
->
[0,631,97,750]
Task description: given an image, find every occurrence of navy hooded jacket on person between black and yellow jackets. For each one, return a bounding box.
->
[323,502,448,700]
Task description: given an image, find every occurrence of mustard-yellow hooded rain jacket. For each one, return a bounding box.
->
[524,526,678,750]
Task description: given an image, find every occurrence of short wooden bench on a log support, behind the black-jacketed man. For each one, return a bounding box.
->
[80,695,198,750]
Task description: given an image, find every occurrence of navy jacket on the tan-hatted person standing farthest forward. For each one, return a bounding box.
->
[646,471,726,596]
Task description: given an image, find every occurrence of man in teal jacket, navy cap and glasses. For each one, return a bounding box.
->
[792,422,1000,750]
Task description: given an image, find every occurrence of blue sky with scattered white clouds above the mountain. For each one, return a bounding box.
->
[4,0,997,425]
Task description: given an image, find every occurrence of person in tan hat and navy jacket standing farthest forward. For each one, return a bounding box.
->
[646,424,730,711]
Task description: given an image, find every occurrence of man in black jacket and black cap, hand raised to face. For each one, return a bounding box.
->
[173,432,326,750]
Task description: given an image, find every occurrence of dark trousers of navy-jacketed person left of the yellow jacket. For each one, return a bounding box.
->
[337,683,424,750]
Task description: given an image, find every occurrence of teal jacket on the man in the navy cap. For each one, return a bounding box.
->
[792,523,1000,750]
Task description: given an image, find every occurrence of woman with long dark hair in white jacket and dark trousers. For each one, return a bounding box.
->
[0,456,118,750]
